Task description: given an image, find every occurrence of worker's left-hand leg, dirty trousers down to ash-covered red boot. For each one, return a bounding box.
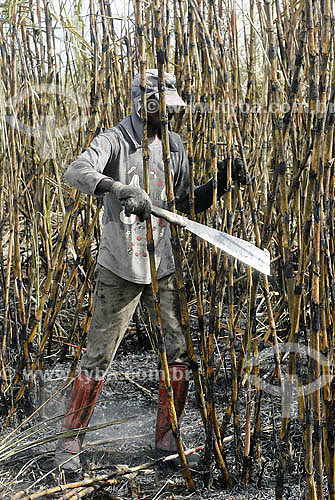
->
[56,266,144,470]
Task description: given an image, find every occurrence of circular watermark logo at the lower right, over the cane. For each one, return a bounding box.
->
[246,342,333,418]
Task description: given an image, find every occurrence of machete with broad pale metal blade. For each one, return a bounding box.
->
[151,206,270,275]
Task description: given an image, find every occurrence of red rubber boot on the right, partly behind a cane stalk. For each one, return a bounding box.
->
[155,365,188,456]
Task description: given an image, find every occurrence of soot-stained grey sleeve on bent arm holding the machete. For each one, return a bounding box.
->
[64,132,120,194]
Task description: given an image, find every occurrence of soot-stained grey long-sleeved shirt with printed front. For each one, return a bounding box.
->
[65,112,189,284]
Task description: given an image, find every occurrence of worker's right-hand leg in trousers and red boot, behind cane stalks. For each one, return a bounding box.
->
[142,275,189,455]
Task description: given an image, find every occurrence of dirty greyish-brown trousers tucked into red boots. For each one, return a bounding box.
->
[80,265,188,380]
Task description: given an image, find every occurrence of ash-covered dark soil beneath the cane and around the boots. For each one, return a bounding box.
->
[0,326,305,500]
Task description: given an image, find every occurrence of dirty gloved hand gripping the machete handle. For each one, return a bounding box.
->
[95,178,151,222]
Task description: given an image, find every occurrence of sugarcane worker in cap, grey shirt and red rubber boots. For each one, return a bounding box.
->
[55,69,246,471]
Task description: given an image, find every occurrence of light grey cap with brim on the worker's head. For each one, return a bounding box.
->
[131,69,186,114]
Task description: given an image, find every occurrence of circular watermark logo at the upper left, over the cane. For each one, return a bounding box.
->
[5,83,88,159]
